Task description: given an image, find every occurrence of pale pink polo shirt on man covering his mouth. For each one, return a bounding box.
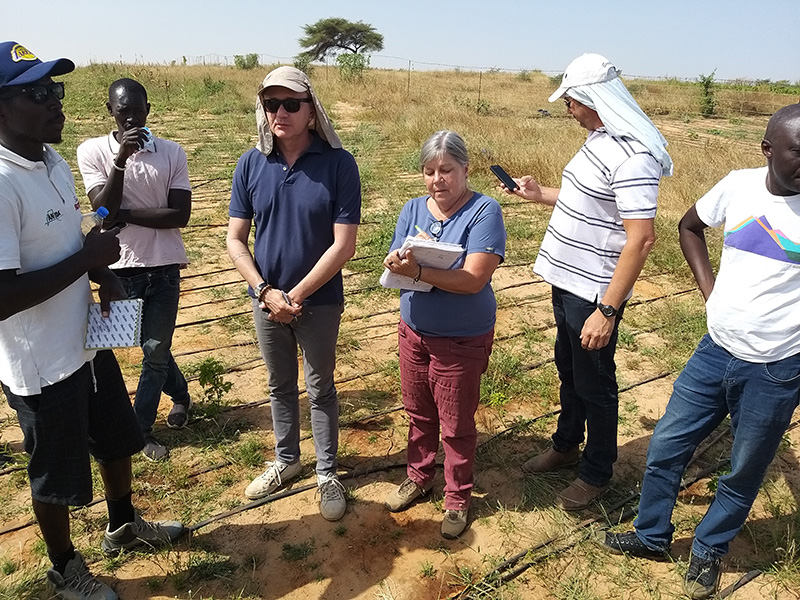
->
[78,132,192,269]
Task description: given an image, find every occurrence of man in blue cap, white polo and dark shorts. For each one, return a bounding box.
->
[0,42,183,600]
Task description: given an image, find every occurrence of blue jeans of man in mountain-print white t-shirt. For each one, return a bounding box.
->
[634,335,800,559]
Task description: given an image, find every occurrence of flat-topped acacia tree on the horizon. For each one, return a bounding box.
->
[299,17,383,60]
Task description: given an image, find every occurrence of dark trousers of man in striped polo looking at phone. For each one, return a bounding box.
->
[553,287,624,486]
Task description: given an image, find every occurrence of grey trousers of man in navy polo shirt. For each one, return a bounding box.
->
[253,300,343,475]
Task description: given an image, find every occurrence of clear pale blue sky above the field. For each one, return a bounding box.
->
[0,0,800,82]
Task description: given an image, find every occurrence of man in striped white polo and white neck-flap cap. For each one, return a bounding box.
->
[514,54,672,510]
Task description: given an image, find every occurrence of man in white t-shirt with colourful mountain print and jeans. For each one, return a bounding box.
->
[601,104,800,599]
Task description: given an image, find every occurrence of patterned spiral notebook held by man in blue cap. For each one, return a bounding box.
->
[85,299,144,350]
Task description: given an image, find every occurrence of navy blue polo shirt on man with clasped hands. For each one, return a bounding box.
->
[228,134,361,304]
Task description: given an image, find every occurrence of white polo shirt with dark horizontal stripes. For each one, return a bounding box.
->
[533,128,661,302]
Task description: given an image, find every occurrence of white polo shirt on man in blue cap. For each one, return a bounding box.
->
[0,145,94,396]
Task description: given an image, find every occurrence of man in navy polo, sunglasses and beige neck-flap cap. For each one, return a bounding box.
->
[228,67,361,521]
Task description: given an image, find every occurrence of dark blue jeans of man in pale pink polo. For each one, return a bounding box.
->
[119,265,189,435]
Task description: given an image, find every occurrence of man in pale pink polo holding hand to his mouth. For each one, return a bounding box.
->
[78,78,192,460]
